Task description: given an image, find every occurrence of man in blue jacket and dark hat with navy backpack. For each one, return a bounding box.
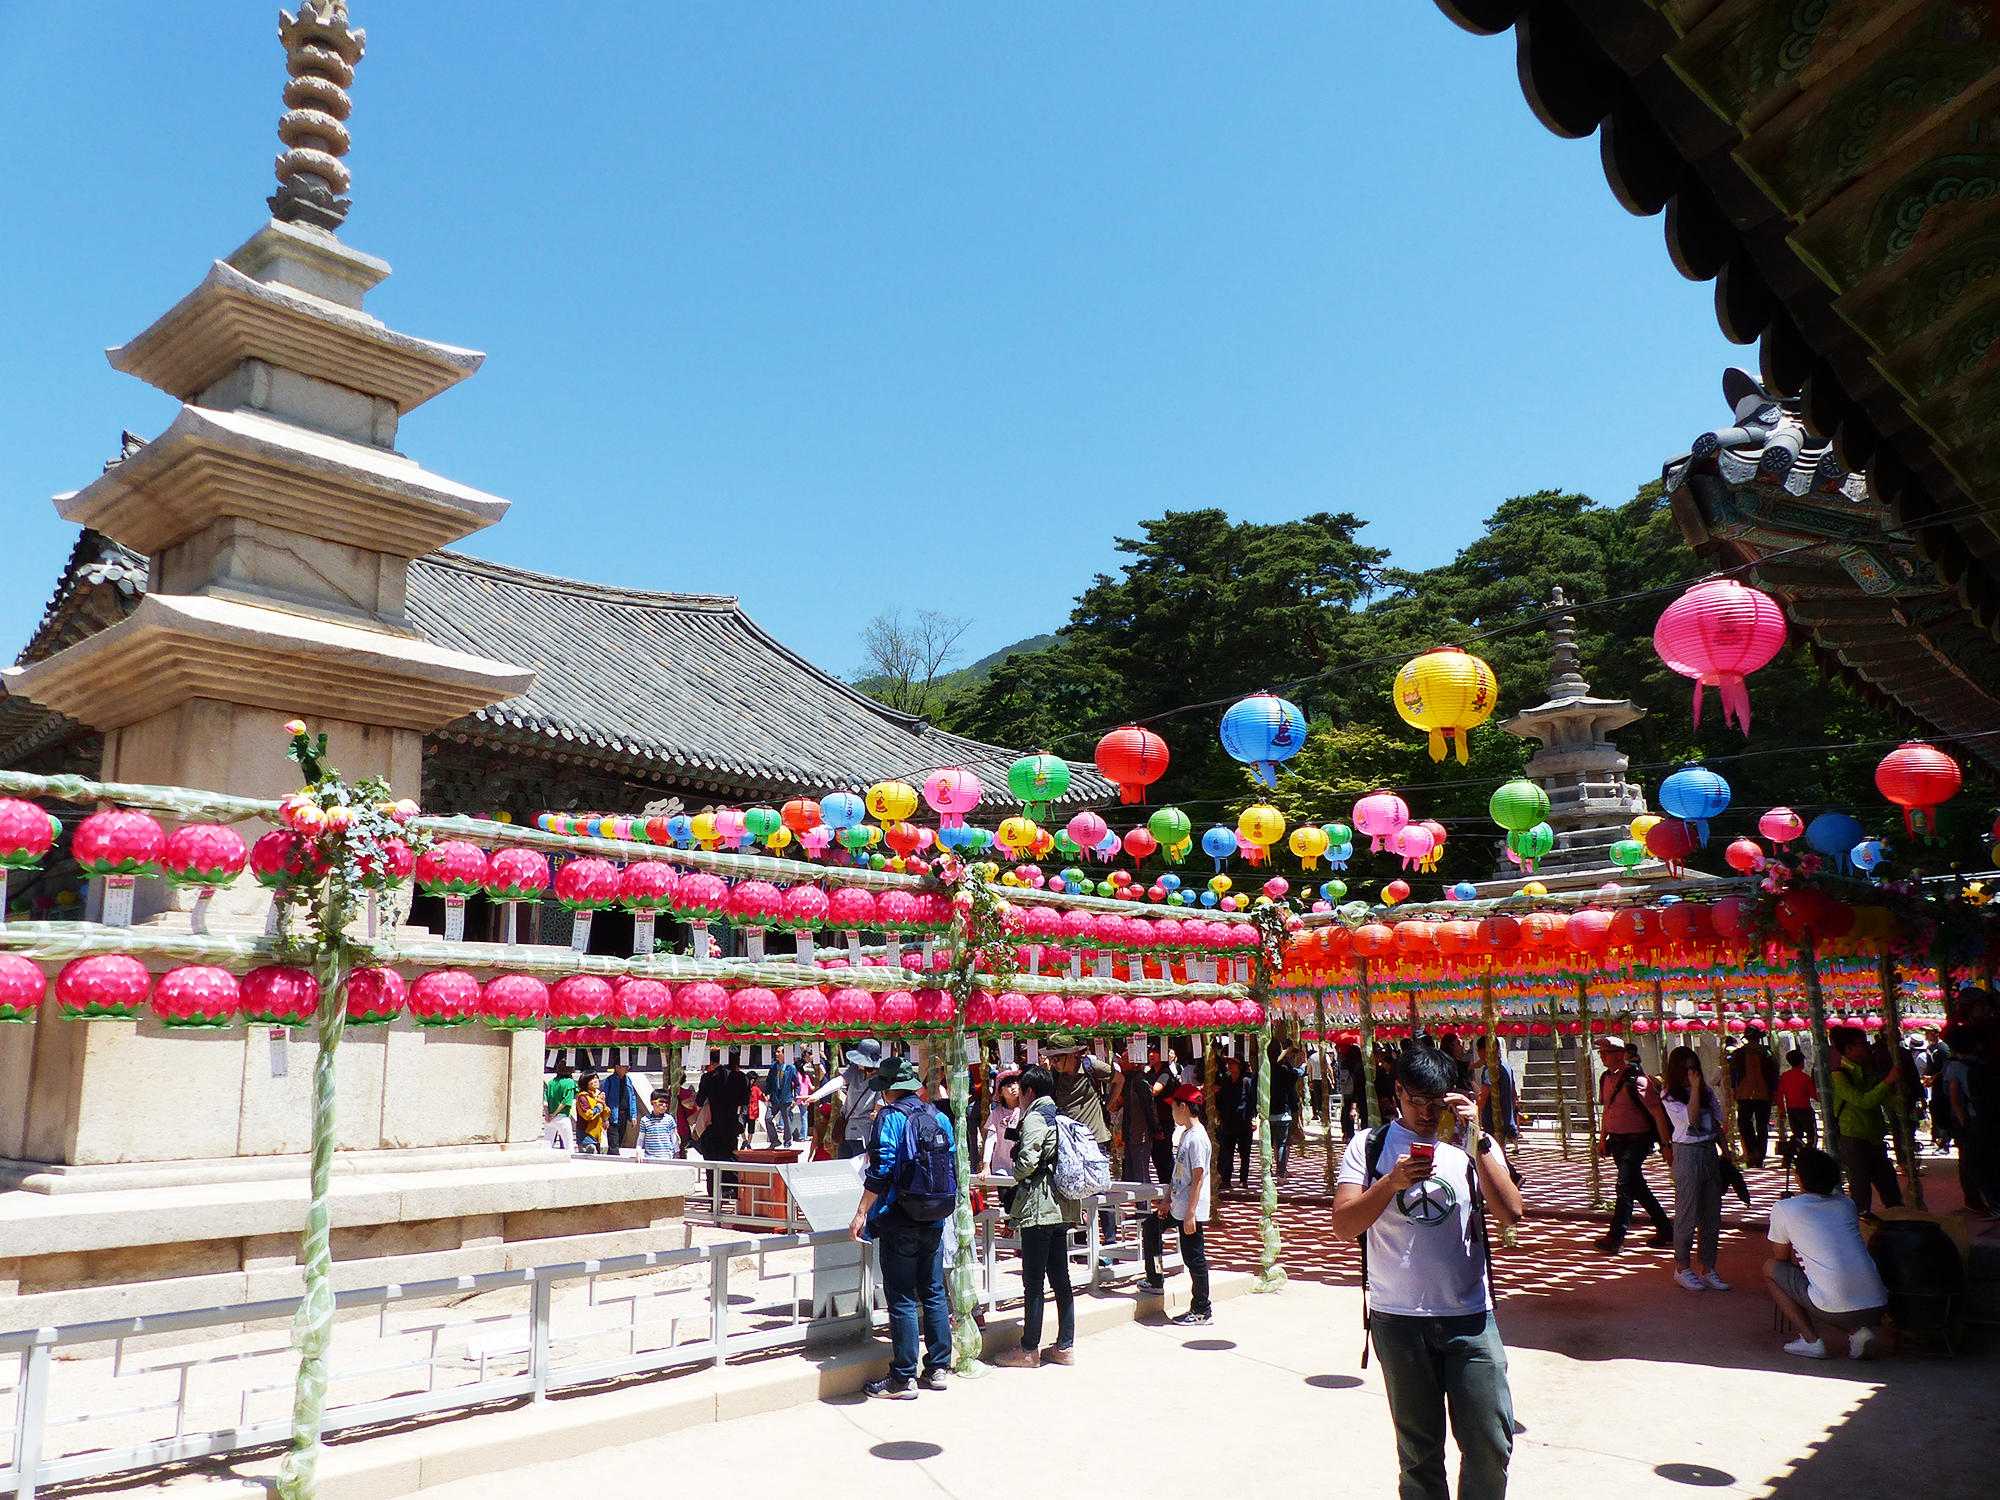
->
[848,1056,958,1400]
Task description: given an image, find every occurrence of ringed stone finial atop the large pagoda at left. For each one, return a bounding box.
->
[270,0,368,230]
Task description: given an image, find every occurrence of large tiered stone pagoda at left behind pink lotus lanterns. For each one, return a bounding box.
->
[0,0,680,1322]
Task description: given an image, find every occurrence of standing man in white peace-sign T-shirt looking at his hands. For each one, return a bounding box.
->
[1334,1046,1520,1500]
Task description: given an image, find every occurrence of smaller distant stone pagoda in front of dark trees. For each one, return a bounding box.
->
[1480,588,1668,896]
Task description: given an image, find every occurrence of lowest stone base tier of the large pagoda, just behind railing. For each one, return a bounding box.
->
[0,1146,698,1328]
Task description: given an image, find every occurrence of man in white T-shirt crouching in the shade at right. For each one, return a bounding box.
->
[1764,1146,1896,1360]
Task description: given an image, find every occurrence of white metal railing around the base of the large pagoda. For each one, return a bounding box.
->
[0,1160,1164,1500]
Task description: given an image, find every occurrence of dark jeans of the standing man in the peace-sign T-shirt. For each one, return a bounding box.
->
[1368,1312,1514,1500]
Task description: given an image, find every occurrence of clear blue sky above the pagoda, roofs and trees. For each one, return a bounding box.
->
[0,0,1754,672]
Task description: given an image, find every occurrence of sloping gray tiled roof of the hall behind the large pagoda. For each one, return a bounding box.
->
[408,552,1116,820]
